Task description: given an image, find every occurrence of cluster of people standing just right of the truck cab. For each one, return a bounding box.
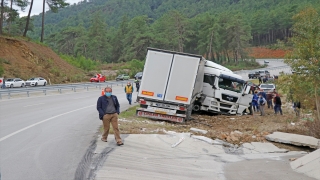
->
[251,89,282,116]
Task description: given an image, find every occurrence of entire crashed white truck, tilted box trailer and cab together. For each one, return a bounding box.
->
[137,48,252,122]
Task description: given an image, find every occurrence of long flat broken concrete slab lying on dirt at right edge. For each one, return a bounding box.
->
[266,132,320,149]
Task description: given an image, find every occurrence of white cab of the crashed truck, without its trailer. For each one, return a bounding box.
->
[200,61,252,114]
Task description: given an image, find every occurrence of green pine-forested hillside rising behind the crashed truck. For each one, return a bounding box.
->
[28,0,320,62]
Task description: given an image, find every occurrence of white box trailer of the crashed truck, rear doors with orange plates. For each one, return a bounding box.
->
[137,48,205,122]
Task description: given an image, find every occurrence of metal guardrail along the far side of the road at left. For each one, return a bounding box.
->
[0,81,133,99]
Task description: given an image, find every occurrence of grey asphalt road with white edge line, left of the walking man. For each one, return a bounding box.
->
[0,87,136,180]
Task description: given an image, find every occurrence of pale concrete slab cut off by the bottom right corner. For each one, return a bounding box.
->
[290,149,320,179]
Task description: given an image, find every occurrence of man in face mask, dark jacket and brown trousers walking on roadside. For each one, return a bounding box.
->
[97,87,123,146]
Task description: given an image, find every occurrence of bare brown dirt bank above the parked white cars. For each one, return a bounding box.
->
[0,37,85,83]
